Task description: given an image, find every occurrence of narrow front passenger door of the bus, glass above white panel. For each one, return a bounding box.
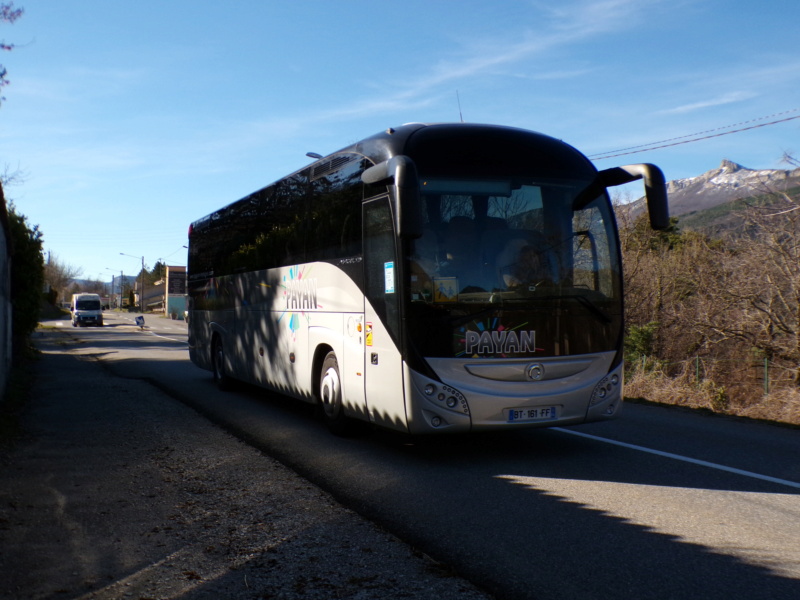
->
[363,196,407,431]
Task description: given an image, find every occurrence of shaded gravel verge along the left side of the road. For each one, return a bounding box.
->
[0,329,489,600]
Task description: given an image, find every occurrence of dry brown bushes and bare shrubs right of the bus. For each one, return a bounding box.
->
[619,159,800,425]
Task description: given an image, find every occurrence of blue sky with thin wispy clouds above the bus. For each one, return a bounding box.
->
[0,0,800,281]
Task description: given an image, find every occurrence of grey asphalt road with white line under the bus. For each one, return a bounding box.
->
[48,313,800,599]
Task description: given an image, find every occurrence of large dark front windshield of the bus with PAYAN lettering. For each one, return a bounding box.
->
[405,178,622,358]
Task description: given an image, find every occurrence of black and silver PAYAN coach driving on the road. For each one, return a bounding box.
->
[187,123,669,434]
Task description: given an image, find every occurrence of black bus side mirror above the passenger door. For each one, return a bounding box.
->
[361,156,422,238]
